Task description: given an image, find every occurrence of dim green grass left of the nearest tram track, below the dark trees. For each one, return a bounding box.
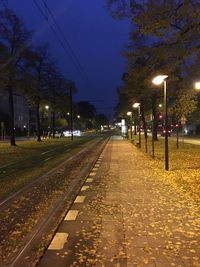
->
[0,136,97,199]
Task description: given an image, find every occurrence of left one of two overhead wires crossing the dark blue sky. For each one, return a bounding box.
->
[33,0,87,82]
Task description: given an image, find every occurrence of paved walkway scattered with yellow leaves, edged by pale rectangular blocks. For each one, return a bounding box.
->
[39,138,200,267]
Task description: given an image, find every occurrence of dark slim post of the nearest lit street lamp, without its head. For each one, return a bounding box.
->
[164,80,169,171]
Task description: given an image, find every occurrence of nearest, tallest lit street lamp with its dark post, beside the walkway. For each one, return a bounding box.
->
[152,75,169,171]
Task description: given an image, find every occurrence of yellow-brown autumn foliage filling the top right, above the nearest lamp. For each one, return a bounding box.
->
[108,0,200,136]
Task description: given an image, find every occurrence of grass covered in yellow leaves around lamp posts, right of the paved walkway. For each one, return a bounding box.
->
[129,136,200,200]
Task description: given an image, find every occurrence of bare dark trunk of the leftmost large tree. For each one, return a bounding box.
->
[8,87,16,146]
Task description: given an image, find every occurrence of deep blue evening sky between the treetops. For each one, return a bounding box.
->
[2,0,130,117]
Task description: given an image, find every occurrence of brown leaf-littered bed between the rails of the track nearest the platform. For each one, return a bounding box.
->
[0,139,107,266]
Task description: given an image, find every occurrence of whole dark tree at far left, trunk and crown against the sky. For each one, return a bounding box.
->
[0,9,31,146]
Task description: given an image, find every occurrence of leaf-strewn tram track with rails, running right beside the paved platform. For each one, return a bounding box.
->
[0,138,108,267]
